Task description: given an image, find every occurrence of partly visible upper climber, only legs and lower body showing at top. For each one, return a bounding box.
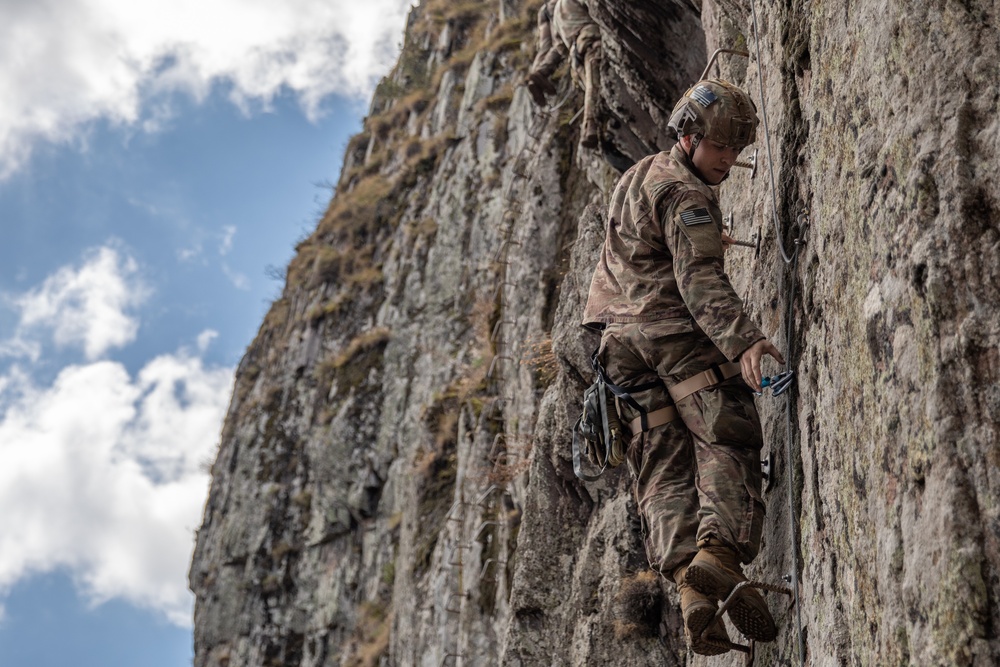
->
[527,0,601,148]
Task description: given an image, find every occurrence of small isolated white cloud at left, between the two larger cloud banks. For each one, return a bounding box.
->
[7,246,148,360]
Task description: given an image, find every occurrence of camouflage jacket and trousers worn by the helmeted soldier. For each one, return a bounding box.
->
[584,145,764,576]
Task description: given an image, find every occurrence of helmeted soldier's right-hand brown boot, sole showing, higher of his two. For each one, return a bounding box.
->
[685,538,778,642]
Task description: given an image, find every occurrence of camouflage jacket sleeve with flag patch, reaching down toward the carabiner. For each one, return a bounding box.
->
[662,193,765,361]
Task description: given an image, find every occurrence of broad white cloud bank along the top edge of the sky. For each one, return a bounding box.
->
[0,0,410,178]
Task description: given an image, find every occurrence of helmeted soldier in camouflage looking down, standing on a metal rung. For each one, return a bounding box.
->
[584,79,784,655]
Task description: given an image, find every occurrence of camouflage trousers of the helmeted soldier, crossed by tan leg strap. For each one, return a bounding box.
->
[599,319,764,577]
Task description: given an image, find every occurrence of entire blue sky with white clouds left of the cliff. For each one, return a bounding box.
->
[0,0,409,667]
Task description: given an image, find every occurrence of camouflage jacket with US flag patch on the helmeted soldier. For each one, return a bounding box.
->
[583,145,764,361]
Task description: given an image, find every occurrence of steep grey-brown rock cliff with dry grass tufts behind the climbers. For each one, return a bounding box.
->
[190,0,1000,667]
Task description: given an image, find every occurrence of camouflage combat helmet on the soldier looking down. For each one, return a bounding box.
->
[667,79,760,148]
